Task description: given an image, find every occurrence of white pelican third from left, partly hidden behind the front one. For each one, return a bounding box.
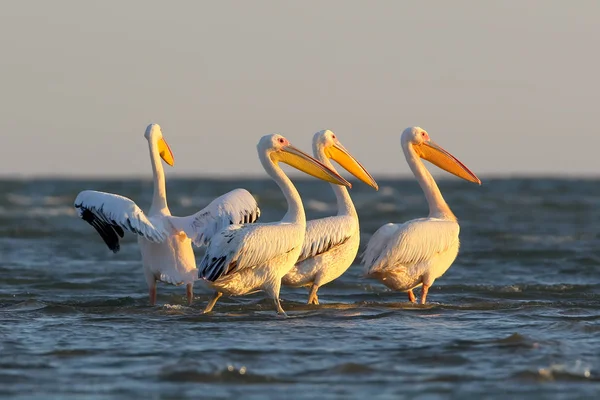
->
[282,130,378,304]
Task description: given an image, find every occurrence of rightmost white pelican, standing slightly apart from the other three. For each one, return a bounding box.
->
[363,127,481,304]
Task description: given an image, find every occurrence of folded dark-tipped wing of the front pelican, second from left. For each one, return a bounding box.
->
[198,223,303,282]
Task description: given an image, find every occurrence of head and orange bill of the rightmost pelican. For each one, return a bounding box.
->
[400,126,481,185]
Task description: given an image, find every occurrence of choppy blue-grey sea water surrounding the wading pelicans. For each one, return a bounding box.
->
[0,178,600,399]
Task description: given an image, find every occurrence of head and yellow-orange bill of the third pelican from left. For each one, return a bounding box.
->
[313,129,379,190]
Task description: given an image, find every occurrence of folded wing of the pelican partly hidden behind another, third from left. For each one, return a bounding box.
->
[297,216,357,263]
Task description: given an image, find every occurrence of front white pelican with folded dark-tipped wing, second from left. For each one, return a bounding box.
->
[198,135,351,315]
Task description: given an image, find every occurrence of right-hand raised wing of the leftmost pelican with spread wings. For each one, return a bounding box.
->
[168,189,260,246]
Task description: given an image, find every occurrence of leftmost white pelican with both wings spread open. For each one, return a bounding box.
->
[75,124,260,305]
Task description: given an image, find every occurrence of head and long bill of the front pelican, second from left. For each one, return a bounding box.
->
[256,134,352,187]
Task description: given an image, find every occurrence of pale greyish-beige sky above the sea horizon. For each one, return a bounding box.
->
[0,0,600,177]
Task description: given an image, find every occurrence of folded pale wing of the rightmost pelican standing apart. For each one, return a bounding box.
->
[363,218,460,273]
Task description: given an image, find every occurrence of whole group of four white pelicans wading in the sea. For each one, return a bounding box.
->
[74,124,481,315]
